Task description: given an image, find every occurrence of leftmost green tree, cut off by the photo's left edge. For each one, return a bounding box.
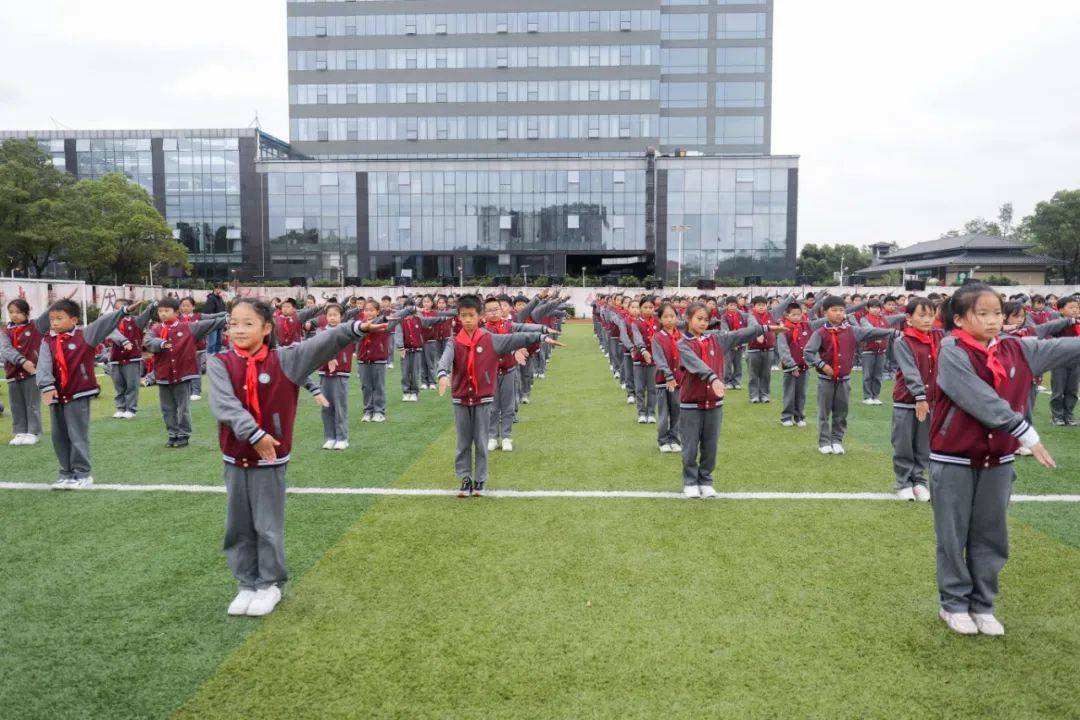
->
[0,139,72,277]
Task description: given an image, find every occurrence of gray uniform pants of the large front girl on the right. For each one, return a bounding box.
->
[930,461,1016,613]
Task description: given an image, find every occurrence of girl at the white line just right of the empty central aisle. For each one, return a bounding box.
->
[677,302,761,498]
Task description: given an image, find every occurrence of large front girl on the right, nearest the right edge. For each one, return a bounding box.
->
[930,283,1080,635]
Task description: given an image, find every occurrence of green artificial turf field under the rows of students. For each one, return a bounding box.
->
[0,324,1080,720]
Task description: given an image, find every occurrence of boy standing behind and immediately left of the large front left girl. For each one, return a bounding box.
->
[143,298,228,448]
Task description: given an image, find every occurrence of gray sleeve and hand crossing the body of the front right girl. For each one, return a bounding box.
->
[937,338,1036,448]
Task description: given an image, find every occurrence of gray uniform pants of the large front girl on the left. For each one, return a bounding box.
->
[225,463,288,590]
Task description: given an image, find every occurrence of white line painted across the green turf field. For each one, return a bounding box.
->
[0,483,1080,503]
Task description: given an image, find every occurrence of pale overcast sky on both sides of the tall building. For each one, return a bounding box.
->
[0,0,1080,250]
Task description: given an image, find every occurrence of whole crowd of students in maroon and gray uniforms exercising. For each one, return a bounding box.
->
[0,284,1080,635]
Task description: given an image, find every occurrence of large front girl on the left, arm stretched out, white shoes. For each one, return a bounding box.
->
[206,299,384,616]
